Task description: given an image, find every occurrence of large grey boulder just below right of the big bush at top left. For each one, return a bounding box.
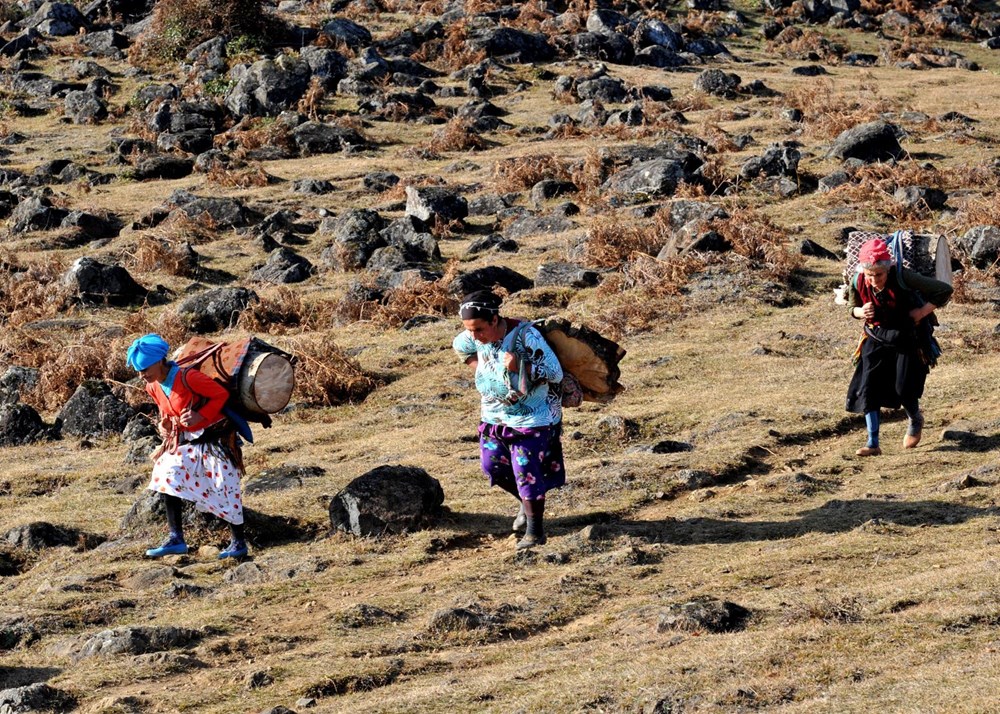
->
[225,55,312,117]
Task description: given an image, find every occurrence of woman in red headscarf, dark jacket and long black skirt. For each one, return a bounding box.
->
[847,238,952,456]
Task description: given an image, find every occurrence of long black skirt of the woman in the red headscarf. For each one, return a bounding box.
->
[847,328,928,414]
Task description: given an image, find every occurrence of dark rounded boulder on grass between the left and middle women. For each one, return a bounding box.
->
[330,466,444,536]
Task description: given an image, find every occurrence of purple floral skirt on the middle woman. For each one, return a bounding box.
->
[479,422,566,501]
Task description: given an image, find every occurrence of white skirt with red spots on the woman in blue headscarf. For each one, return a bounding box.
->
[149,444,243,525]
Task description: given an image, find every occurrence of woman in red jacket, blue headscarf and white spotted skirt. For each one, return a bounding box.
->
[128,335,247,558]
